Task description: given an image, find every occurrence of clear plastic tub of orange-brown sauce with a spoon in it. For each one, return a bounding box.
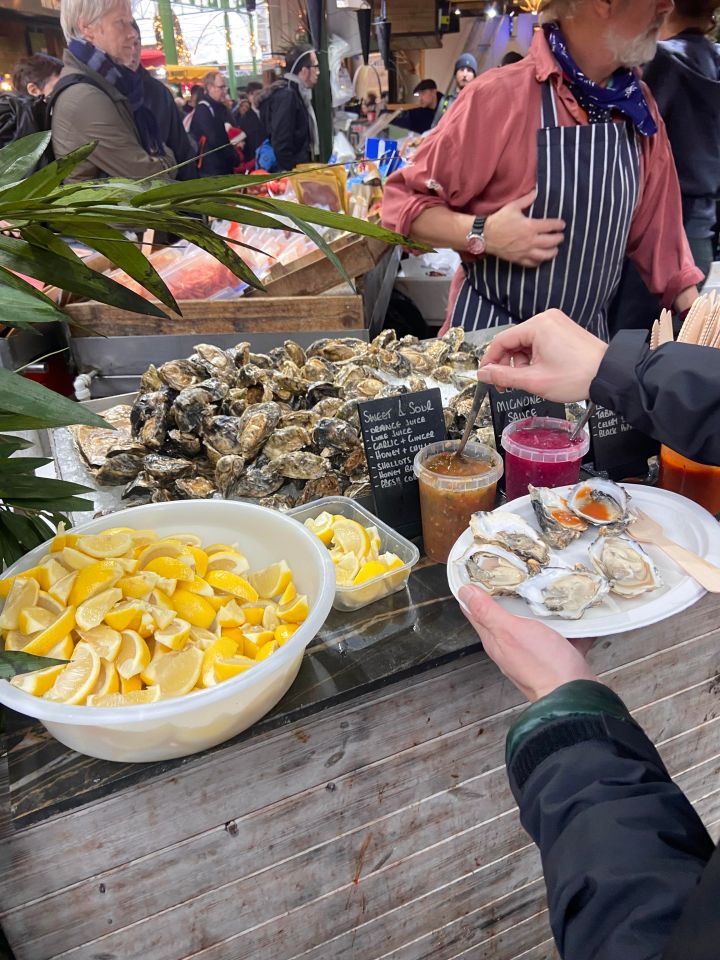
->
[413,440,503,563]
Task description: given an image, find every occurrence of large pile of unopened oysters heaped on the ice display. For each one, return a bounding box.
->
[71,328,492,510]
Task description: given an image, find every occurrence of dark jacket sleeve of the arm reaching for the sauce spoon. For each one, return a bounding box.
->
[590,330,720,465]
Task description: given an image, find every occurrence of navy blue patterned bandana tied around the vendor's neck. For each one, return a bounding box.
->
[543,23,657,137]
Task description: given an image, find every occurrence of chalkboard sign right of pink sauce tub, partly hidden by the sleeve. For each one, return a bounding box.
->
[590,407,660,480]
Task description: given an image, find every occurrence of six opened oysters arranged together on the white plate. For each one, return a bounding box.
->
[460,478,662,620]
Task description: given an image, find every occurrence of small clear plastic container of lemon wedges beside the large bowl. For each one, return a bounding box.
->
[288,497,420,611]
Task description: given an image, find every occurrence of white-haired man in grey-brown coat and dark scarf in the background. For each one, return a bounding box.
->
[51,0,175,180]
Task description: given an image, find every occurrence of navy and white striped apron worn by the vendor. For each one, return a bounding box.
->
[452,82,640,340]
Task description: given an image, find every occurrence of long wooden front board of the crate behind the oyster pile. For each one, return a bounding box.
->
[66,294,364,338]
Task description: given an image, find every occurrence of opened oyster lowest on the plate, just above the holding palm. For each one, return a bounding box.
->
[515,567,610,620]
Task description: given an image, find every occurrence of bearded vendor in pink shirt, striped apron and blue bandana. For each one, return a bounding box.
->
[383,0,702,340]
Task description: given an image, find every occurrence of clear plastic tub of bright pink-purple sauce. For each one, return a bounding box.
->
[501,417,590,500]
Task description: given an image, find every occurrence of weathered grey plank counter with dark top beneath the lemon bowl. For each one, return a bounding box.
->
[0,565,720,960]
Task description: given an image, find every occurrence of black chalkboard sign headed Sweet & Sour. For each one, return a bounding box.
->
[358,389,446,537]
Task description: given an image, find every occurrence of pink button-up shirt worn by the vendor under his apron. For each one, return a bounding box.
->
[383,30,702,307]
